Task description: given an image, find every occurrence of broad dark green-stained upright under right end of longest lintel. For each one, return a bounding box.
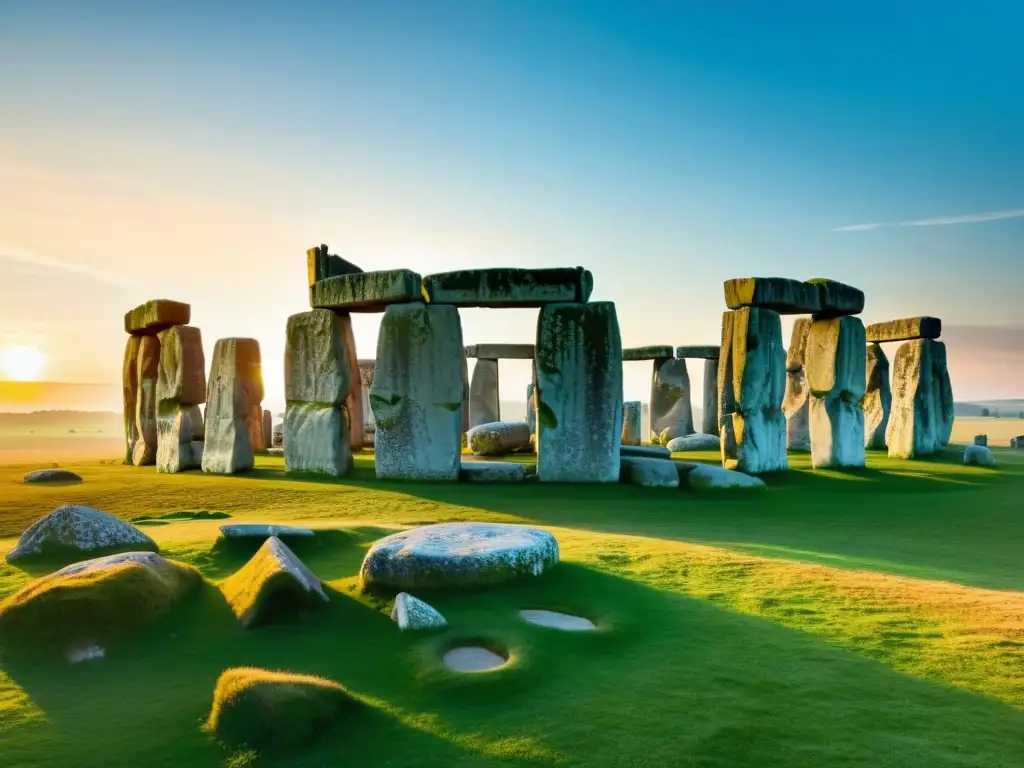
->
[536,301,623,482]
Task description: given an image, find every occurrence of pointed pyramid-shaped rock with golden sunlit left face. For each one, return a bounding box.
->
[220,536,330,627]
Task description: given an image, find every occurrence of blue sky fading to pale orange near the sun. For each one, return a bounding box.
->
[0,0,1024,415]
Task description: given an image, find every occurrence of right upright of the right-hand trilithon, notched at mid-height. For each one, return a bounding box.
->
[807,315,867,468]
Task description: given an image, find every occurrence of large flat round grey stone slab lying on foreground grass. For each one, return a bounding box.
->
[359,522,558,590]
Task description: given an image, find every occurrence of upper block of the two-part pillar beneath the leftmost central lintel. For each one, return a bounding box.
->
[285,309,352,407]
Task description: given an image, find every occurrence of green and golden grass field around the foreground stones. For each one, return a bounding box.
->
[0,448,1024,767]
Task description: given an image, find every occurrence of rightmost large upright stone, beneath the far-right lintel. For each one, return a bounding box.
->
[886,339,939,459]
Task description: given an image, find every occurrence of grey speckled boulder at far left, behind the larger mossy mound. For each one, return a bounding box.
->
[7,504,158,562]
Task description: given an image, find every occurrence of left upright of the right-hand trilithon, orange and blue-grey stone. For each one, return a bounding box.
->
[718,307,790,474]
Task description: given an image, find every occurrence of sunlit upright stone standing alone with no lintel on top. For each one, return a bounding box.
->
[203,339,263,474]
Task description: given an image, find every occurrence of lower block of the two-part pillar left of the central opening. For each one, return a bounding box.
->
[285,402,352,477]
